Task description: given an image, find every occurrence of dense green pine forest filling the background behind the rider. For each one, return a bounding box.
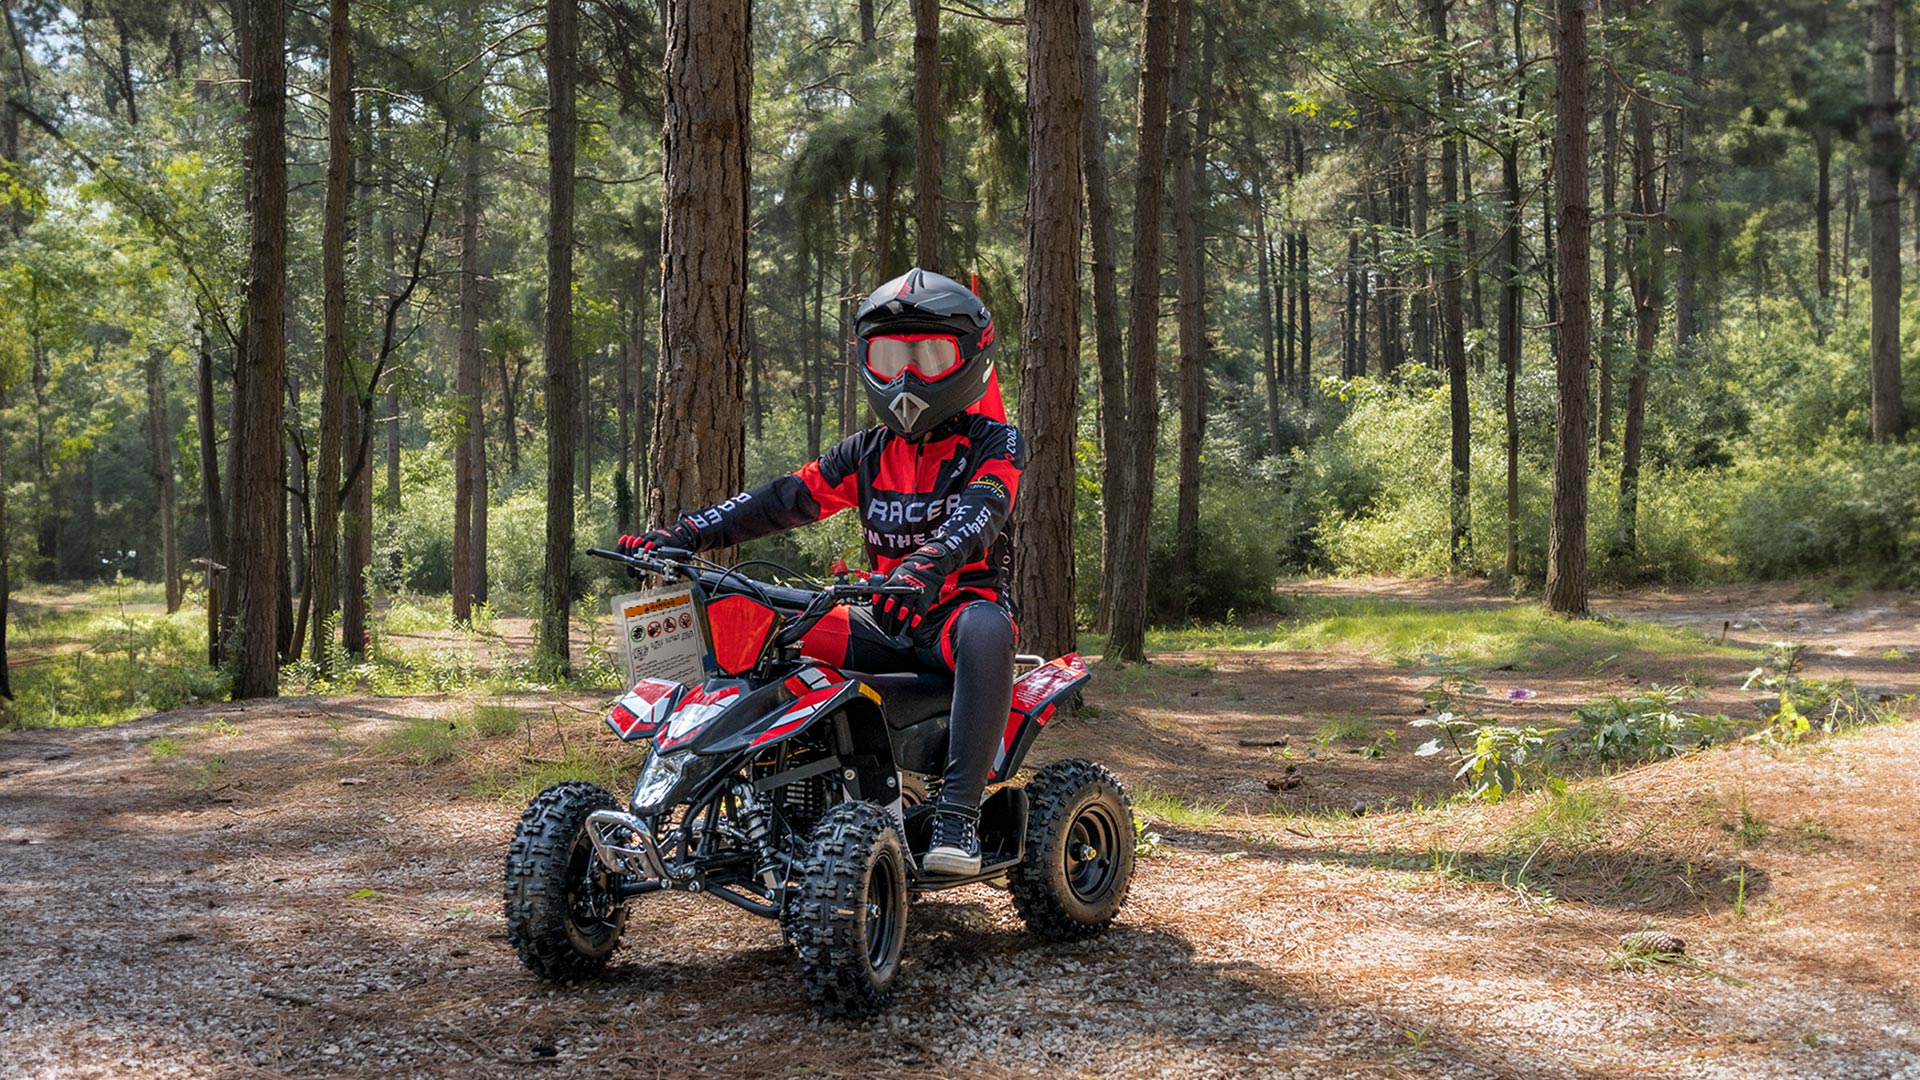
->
[0,0,1920,723]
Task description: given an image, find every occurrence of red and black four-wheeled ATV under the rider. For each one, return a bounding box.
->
[505,550,1135,1017]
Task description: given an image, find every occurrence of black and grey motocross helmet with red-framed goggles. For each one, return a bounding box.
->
[854,267,993,440]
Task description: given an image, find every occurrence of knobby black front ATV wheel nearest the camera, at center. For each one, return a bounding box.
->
[785,803,906,1017]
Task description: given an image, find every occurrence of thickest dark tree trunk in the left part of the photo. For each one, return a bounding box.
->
[223,4,286,700]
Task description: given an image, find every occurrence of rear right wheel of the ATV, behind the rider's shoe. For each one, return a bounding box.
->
[1006,759,1133,942]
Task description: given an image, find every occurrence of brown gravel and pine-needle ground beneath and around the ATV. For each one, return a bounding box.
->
[0,584,1920,1080]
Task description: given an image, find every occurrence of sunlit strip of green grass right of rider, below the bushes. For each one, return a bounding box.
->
[1085,596,1753,671]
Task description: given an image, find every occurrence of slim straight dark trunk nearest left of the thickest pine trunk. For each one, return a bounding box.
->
[538,0,580,675]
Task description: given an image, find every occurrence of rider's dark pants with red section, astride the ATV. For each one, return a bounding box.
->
[801,600,1014,809]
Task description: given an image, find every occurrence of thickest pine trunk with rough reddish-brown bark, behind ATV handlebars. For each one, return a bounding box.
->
[647,0,752,538]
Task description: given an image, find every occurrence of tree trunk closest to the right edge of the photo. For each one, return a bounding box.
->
[1866,0,1907,442]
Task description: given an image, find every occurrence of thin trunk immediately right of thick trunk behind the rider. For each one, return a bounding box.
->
[1079,0,1127,630]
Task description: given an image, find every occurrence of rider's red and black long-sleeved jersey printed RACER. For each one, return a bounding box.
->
[682,413,1027,605]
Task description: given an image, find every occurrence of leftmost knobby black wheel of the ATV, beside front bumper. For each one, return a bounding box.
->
[503,780,626,980]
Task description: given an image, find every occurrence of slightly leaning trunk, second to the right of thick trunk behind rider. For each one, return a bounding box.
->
[1104,0,1192,663]
